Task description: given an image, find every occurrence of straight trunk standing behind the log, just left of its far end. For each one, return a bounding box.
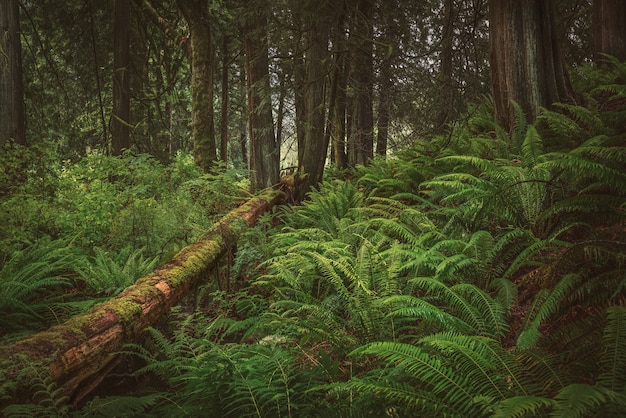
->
[244,4,280,191]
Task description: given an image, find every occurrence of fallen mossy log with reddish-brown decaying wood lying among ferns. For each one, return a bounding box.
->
[0,189,284,405]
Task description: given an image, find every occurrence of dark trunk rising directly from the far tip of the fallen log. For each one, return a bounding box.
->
[298,1,329,199]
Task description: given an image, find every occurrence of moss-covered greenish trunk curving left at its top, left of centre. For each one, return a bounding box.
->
[176,0,217,173]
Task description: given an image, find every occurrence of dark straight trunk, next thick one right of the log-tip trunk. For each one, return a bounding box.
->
[348,0,374,166]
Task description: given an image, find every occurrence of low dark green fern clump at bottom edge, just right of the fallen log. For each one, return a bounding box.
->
[122,320,327,417]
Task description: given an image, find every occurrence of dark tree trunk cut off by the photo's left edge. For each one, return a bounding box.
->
[0,0,26,146]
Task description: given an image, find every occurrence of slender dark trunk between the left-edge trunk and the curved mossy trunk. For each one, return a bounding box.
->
[111,0,130,155]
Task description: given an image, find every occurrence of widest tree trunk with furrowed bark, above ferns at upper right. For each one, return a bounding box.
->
[489,0,571,136]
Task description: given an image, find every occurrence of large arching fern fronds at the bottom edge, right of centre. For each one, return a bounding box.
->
[346,333,533,417]
